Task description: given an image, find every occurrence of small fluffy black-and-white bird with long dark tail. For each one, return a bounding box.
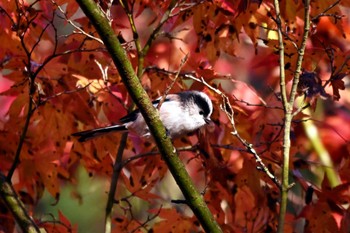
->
[72,91,213,142]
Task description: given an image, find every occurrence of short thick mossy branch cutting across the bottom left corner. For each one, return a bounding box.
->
[0,172,40,233]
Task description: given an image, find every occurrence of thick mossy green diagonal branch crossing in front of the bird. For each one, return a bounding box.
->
[77,0,222,232]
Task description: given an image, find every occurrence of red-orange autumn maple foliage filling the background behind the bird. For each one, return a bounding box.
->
[0,0,350,232]
